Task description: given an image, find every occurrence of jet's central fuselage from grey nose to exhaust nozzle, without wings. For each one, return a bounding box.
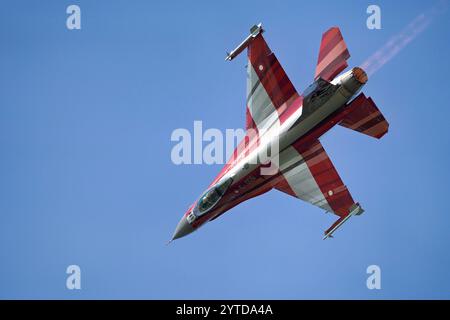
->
[173,68,367,239]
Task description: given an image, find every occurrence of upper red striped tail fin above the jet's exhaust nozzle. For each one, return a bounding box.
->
[314,27,350,81]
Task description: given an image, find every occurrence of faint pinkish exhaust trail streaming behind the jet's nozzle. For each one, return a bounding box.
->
[361,0,449,76]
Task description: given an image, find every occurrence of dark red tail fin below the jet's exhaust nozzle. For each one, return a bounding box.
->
[339,93,389,139]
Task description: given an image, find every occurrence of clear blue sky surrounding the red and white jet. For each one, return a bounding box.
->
[0,1,450,299]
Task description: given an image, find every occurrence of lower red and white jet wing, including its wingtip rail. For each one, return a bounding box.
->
[275,140,364,238]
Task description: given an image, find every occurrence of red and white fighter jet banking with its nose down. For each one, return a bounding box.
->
[171,24,389,241]
